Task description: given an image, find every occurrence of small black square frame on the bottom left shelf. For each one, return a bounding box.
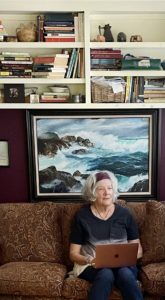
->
[4,84,25,103]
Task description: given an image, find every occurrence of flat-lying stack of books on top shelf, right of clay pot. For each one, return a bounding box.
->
[44,12,75,42]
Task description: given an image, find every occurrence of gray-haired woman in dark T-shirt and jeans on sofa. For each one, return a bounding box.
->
[70,171,143,300]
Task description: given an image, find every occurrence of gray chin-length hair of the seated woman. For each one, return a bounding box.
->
[82,170,118,202]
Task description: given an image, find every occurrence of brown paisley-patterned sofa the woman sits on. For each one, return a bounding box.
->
[0,200,165,300]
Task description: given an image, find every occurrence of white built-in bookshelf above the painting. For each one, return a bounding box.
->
[0,0,165,109]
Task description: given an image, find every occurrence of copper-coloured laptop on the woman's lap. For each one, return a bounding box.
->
[95,243,138,268]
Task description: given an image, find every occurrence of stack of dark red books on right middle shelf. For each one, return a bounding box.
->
[91,49,123,70]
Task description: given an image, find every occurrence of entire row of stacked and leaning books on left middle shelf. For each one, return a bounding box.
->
[0,48,85,78]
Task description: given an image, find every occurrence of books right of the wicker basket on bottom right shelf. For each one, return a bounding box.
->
[125,76,165,103]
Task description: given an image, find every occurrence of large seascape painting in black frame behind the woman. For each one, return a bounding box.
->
[27,109,158,202]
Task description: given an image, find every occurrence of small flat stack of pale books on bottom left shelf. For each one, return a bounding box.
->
[40,86,70,103]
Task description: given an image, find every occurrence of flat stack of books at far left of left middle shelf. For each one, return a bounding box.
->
[0,52,33,78]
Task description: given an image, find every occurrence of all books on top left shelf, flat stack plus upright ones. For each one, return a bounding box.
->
[37,12,84,42]
